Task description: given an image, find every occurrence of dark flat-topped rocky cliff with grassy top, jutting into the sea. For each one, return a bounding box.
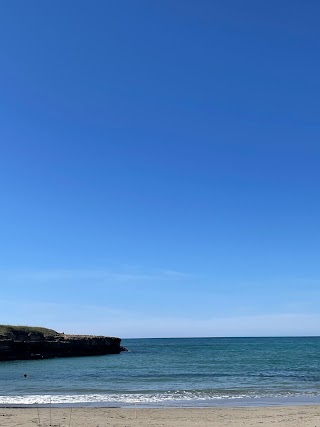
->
[0,325,126,361]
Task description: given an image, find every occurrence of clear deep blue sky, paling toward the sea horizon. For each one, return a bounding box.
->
[0,0,320,338]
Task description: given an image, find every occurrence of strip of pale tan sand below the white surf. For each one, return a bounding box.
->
[0,405,320,427]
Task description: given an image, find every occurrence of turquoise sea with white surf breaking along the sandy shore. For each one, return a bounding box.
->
[0,337,320,406]
